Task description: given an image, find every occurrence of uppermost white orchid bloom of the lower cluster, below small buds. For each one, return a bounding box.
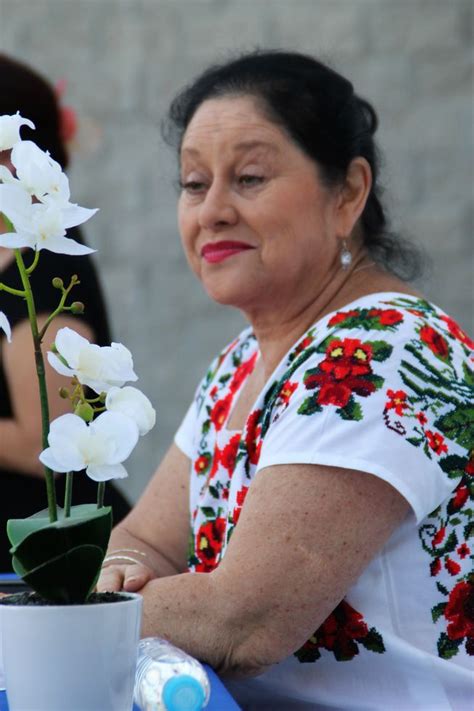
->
[48,327,138,393]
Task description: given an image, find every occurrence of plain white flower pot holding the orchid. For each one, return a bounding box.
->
[0,593,142,711]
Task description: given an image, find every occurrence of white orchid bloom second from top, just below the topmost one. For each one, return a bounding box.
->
[10,141,71,206]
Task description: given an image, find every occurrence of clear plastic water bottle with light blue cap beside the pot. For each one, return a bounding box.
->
[134,637,211,711]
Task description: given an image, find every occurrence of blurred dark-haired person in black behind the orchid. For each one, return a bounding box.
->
[0,53,130,572]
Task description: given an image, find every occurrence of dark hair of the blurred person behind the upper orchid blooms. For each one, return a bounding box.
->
[0,52,68,169]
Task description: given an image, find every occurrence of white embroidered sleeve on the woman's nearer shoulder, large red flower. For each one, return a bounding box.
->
[257,324,468,522]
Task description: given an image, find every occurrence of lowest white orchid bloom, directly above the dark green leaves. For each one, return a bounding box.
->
[39,412,139,481]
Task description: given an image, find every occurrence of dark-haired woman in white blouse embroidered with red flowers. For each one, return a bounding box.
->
[99,52,474,711]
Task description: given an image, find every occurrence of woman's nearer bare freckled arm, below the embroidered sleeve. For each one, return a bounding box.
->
[99,465,409,676]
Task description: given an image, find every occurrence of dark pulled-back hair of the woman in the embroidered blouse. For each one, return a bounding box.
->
[163,50,421,279]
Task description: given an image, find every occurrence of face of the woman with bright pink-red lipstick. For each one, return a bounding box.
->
[178,97,339,311]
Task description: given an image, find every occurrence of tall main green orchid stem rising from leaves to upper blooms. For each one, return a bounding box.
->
[15,249,58,523]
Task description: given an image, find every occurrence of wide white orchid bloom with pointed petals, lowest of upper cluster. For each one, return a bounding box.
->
[0,181,97,255]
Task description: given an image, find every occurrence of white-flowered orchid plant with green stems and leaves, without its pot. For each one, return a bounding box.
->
[0,113,155,603]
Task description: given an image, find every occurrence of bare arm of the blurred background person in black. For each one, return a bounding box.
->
[0,314,93,477]
